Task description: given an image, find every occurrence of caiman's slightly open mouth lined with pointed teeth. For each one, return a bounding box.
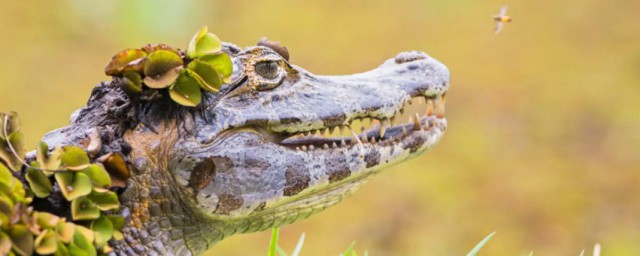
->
[256,94,446,151]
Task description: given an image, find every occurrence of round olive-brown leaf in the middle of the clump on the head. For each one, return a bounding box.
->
[144,50,183,89]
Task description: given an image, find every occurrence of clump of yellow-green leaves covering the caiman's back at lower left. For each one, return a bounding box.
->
[0,113,124,255]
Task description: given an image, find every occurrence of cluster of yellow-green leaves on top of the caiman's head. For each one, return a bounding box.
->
[105,27,233,107]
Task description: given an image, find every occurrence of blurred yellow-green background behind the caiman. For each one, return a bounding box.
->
[0,0,640,255]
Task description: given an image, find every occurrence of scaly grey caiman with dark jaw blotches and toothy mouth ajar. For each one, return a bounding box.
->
[43,43,450,255]
